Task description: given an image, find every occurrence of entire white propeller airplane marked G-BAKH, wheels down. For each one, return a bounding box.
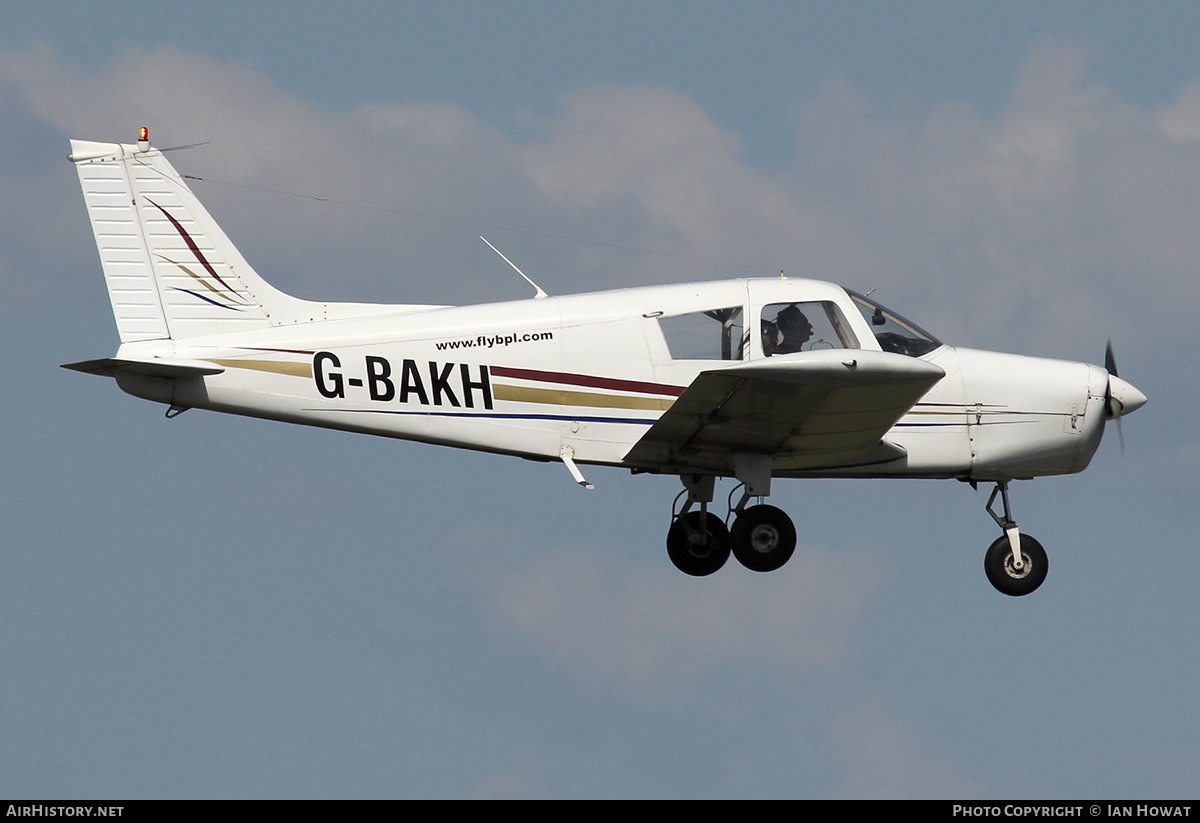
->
[65,130,1146,595]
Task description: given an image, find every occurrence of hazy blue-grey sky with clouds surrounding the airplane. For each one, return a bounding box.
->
[0,2,1200,798]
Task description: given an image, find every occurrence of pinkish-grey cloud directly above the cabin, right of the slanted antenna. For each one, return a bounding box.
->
[523,86,827,276]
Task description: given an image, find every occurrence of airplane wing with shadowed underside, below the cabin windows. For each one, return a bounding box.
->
[625,349,946,474]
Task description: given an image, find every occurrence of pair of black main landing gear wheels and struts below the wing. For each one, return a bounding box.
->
[667,468,796,577]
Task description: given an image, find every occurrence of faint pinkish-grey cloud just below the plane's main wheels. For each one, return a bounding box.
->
[484,546,880,702]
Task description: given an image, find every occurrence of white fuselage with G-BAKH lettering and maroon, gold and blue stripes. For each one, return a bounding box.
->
[110,280,1106,480]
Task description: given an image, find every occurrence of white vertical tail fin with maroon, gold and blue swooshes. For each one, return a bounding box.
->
[71,133,324,343]
